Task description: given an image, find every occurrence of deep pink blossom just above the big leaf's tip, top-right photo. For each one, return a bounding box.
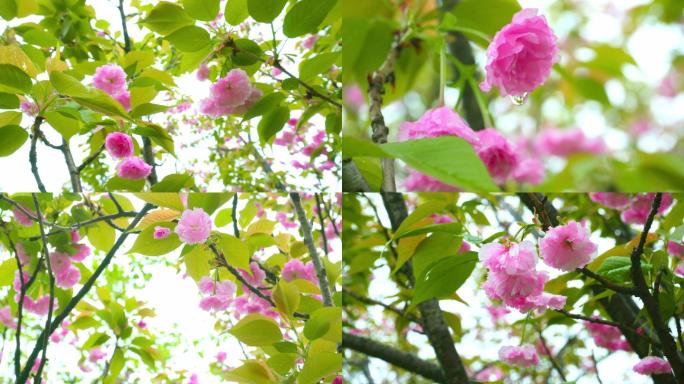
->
[475,128,519,184]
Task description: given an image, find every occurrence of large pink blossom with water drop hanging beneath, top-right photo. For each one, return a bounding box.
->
[480,8,558,96]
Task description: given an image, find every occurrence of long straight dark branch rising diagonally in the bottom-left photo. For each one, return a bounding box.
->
[17,204,154,384]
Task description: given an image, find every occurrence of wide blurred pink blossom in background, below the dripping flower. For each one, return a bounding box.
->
[534,128,606,157]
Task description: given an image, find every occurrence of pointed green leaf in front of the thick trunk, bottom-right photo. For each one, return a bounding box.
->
[411,252,477,308]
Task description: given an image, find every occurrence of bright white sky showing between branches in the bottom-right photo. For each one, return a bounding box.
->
[359,194,664,384]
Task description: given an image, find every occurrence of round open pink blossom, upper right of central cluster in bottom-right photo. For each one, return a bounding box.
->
[539,221,598,271]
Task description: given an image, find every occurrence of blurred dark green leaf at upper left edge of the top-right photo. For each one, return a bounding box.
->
[342,17,393,81]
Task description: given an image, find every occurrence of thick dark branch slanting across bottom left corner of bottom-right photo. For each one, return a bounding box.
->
[342,332,448,383]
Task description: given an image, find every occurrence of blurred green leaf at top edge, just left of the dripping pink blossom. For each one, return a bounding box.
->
[451,0,521,47]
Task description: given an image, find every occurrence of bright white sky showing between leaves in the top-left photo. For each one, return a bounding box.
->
[0,0,341,191]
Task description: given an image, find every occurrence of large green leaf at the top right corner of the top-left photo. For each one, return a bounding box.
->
[283,0,337,37]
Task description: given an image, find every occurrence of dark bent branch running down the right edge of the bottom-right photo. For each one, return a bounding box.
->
[630,193,684,382]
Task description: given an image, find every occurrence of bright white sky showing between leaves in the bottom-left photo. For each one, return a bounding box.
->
[0,196,342,384]
